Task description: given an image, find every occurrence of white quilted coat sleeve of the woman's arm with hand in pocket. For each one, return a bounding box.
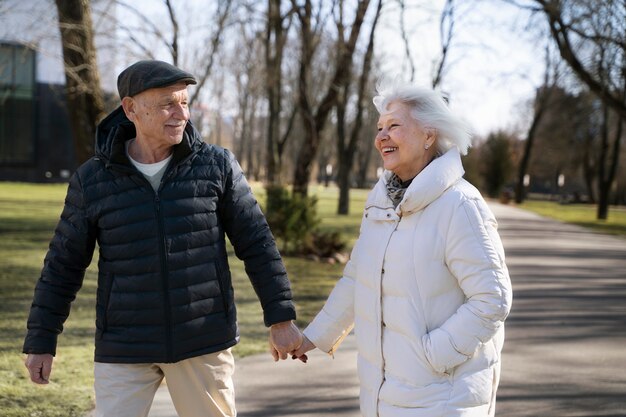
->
[422,199,512,372]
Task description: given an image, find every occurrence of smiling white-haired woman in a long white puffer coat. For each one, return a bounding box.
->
[293,86,511,417]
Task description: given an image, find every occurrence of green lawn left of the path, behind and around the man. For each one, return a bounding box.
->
[0,183,367,417]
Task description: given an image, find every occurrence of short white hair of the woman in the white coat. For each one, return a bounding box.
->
[374,84,471,155]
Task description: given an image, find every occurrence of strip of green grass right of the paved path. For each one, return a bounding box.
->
[519,201,626,236]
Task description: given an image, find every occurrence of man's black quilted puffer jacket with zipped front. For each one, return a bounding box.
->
[24,108,295,363]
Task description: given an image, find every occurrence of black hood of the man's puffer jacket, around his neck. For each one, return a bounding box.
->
[95,106,204,163]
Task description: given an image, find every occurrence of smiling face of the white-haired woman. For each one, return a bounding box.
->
[375,101,435,181]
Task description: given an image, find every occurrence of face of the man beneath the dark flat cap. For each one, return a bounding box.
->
[122,83,189,149]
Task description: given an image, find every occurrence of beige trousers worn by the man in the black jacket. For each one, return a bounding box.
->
[94,349,237,417]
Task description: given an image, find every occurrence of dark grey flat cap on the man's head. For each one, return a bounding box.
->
[117,60,198,98]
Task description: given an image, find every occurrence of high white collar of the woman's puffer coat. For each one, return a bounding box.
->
[365,148,465,216]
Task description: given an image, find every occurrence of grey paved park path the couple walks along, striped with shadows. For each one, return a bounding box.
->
[145,204,626,417]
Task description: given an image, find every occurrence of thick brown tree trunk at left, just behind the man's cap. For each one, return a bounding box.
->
[56,0,105,164]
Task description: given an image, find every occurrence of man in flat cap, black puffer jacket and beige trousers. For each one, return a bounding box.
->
[24,61,302,417]
